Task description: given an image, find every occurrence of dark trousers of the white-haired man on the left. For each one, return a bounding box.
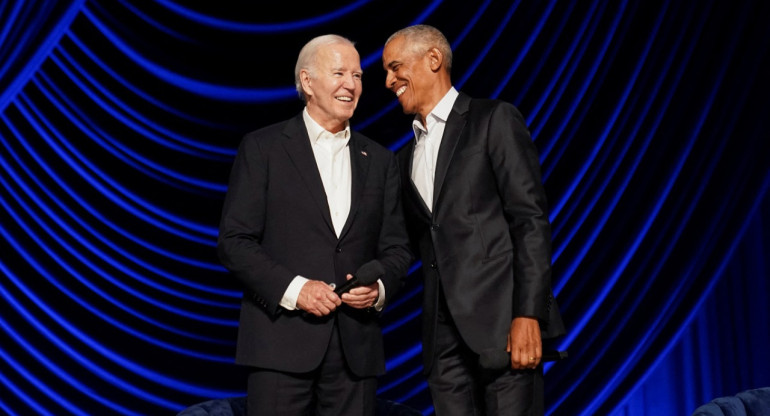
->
[246,322,377,416]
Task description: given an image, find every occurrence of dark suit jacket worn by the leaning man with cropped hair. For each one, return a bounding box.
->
[398,93,564,371]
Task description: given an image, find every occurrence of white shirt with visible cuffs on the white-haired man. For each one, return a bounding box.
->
[280,107,385,310]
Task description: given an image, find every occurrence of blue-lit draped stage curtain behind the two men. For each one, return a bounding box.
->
[0,0,770,415]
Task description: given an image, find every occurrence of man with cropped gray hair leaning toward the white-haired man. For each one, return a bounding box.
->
[382,25,564,416]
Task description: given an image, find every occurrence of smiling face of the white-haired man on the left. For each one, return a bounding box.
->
[300,43,363,133]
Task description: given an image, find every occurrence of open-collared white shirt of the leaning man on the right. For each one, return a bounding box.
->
[412,87,459,212]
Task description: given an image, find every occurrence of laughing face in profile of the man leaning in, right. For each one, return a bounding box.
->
[382,36,444,122]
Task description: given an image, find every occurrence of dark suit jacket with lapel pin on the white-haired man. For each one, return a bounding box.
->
[218,114,412,376]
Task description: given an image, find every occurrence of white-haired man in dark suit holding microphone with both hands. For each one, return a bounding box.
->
[218,35,412,416]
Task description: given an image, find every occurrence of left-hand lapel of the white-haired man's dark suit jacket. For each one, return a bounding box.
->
[283,113,336,235]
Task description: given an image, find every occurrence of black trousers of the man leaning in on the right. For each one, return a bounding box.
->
[428,291,544,416]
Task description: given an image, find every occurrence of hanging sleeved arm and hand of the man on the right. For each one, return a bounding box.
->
[489,104,551,369]
